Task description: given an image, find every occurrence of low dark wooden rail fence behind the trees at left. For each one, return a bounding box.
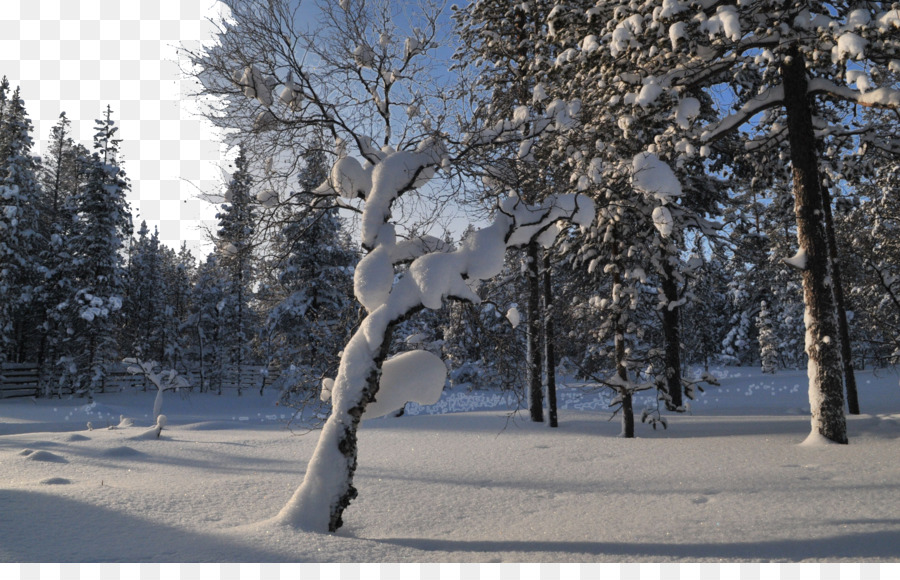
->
[0,363,278,399]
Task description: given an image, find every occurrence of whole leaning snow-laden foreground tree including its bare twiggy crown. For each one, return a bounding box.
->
[188,0,593,531]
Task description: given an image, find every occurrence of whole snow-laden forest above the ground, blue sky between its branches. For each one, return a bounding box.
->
[0,0,900,531]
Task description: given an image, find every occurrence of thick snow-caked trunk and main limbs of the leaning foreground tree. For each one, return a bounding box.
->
[275,188,594,531]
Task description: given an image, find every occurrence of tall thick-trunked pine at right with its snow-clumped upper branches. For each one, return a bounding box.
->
[552,1,900,443]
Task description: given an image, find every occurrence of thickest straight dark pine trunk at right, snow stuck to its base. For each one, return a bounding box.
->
[781,45,847,443]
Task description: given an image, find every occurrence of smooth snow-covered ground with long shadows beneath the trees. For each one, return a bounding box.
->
[0,369,900,562]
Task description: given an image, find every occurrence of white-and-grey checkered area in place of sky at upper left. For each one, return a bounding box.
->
[0,0,225,257]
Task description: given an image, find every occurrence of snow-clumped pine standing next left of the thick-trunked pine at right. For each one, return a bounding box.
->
[541,2,723,410]
